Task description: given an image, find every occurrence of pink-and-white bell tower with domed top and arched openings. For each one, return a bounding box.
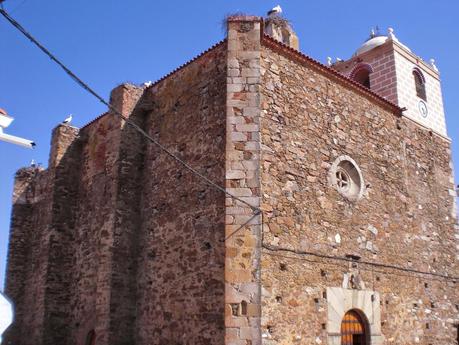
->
[331,28,447,136]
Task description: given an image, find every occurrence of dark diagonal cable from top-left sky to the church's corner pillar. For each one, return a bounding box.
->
[0,7,261,212]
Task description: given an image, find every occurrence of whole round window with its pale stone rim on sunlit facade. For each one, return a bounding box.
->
[329,156,364,201]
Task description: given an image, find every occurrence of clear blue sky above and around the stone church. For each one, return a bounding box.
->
[0,0,459,286]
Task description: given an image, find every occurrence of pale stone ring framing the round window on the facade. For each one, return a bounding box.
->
[328,155,365,202]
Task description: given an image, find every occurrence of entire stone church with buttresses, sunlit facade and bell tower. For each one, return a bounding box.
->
[4,14,459,345]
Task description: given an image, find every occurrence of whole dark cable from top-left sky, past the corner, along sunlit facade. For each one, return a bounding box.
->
[0,7,459,282]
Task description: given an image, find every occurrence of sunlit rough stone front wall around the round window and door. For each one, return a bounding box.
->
[261,41,459,345]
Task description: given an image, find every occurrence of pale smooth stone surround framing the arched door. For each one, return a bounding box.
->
[327,287,384,345]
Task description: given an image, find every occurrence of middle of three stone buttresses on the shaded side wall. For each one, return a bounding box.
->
[40,125,81,344]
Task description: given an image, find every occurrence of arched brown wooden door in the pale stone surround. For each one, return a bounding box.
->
[341,310,369,345]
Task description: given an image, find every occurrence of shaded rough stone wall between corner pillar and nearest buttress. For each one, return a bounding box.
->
[132,44,226,345]
